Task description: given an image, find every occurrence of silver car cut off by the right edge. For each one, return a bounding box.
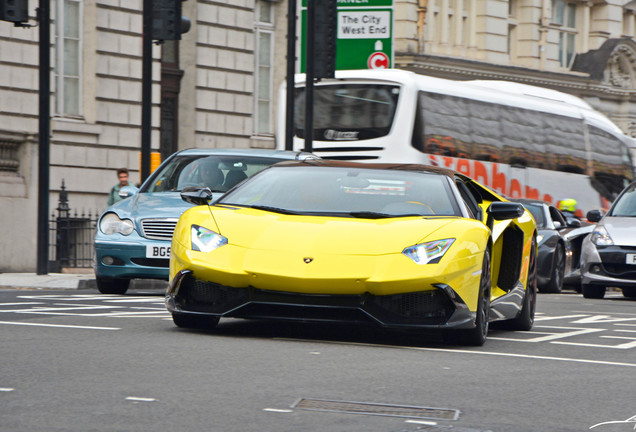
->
[581,182,636,298]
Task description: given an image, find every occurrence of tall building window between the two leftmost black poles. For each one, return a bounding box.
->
[55,0,82,116]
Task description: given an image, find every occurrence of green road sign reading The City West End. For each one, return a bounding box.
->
[300,0,393,72]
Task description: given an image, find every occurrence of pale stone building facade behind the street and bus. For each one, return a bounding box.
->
[0,0,636,271]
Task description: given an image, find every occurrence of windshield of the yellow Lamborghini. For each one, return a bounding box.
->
[215,166,461,219]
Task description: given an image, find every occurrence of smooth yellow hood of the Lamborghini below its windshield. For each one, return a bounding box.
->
[211,207,457,255]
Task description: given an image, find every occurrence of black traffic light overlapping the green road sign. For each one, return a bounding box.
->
[309,0,338,79]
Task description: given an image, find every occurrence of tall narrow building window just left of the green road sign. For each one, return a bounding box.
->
[254,0,274,135]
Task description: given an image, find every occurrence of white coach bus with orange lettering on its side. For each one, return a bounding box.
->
[276,70,633,214]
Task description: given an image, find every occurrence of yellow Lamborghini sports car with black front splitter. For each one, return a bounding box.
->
[166,160,536,345]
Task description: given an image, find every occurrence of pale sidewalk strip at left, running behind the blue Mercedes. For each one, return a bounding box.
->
[0,269,168,291]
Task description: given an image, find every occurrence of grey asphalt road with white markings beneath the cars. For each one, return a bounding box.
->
[0,290,636,432]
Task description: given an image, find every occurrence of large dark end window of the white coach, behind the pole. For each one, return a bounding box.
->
[294,84,400,141]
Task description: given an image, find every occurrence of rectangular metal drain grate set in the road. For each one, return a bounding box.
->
[292,398,459,420]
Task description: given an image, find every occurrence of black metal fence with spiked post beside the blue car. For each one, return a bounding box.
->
[48,181,100,272]
